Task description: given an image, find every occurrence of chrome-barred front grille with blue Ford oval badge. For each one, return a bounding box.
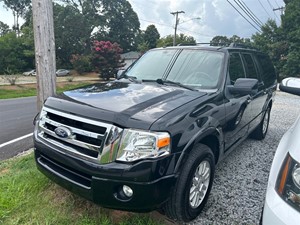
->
[38,107,122,163]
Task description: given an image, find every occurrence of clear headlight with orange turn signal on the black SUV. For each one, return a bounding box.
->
[117,129,171,162]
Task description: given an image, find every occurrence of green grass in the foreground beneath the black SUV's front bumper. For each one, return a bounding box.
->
[0,153,164,225]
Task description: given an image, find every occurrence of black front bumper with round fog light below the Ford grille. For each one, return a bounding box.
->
[35,137,176,212]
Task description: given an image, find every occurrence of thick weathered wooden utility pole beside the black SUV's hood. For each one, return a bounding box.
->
[32,0,56,110]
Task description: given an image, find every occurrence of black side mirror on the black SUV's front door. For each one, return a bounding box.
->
[227,78,258,96]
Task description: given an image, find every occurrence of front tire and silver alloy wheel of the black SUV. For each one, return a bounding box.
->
[164,144,215,222]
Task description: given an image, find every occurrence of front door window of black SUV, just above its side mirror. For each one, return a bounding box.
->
[229,53,245,83]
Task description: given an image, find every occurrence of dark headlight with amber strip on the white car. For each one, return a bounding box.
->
[276,155,300,211]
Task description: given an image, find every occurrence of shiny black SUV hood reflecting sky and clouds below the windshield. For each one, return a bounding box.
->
[53,81,205,129]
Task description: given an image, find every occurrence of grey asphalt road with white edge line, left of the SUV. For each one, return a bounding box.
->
[0,97,37,160]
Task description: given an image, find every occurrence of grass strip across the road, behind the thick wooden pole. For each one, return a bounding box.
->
[0,81,95,99]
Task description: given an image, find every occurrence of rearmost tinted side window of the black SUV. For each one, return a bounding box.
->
[256,54,276,87]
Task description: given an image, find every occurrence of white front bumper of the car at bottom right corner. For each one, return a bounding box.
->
[262,186,300,225]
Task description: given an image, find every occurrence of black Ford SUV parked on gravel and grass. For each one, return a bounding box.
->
[34,46,276,221]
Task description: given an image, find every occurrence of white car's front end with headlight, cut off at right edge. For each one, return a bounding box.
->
[262,116,300,225]
